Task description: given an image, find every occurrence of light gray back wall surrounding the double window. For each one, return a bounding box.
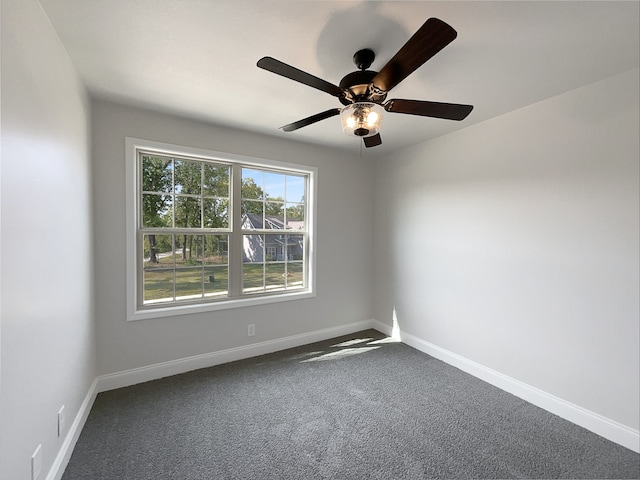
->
[92,101,373,375]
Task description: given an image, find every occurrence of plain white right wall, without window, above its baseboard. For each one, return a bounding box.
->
[374,70,640,435]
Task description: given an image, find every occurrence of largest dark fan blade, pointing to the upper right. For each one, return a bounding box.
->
[371,18,458,92]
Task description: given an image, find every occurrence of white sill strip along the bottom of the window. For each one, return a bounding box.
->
[127,291,316,322]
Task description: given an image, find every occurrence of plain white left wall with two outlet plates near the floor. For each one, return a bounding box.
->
[0,0,96,480]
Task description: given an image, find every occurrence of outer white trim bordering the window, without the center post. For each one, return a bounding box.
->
[125,137,318,321]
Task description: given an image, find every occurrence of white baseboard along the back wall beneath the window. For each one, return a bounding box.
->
[97,320,374,392]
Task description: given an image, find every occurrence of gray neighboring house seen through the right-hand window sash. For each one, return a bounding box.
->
[242,213,304,262]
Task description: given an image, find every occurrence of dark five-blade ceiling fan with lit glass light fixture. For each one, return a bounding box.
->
[258,18,473,147]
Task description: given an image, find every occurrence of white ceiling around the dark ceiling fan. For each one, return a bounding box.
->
[40,0,640,154]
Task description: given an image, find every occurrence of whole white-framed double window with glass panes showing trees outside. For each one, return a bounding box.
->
[127,138,315,319]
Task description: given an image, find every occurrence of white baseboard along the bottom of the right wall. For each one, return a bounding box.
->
[373,320,640,453]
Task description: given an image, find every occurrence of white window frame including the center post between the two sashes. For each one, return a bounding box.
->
[125,137,318,321]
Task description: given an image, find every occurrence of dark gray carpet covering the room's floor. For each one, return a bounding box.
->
[63,330,640,480]
